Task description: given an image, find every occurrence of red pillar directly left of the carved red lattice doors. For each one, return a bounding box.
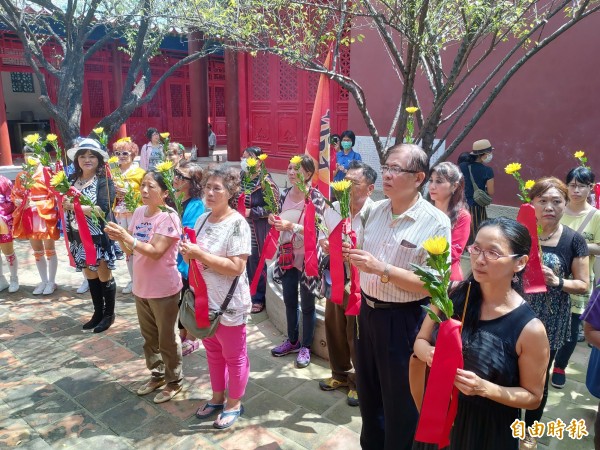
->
[225,49,241,161]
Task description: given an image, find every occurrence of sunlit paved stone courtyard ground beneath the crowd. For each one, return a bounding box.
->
[0,237,597,450]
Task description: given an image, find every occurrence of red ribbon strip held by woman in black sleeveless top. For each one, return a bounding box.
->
[415,319,463,448]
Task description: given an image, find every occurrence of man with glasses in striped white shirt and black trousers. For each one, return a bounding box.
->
[347,144,451,450]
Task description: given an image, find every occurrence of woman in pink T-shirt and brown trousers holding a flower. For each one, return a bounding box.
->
[106,169,183,403]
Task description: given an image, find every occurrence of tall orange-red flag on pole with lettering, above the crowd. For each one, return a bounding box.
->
[304,50,331,199]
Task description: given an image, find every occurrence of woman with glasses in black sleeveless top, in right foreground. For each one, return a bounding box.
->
[414,218,549,450]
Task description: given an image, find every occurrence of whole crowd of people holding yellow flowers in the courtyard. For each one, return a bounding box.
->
[0,128,600,450]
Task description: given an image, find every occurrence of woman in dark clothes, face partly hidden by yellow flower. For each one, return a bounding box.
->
[242,147,279,314]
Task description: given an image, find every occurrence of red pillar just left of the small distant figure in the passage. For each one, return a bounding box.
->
[188,31,209,156]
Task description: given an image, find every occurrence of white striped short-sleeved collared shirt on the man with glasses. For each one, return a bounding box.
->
[359,194,451,303]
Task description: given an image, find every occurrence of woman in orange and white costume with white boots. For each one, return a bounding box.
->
[12,141,60,295]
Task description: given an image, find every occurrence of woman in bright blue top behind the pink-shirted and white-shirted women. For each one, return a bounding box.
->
[173,159,205,356]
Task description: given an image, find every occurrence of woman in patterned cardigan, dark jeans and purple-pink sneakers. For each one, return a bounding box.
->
[269,155,325,368]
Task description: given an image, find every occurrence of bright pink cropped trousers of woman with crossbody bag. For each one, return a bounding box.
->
[202,324,250,399]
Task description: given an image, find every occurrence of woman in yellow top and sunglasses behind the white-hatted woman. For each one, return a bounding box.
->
[113,139,146,294]
